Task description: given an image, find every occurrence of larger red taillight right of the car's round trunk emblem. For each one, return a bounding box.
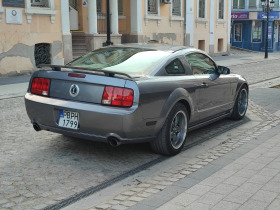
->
[101,86,134,107]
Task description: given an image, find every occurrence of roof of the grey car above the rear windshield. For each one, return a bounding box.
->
[108,43,200,52]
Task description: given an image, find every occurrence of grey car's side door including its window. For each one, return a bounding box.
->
[185,53,231,120]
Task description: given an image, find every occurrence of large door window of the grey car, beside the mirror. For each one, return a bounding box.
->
[186,53,216,74]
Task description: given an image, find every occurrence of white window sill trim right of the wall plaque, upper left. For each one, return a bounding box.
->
[25,0,56,23]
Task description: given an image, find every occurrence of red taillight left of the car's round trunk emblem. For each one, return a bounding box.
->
[31,77,50,96]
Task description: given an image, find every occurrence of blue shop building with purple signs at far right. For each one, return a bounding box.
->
[231,0,280,52]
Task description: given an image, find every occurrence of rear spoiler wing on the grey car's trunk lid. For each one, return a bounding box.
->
[38,64,133,79]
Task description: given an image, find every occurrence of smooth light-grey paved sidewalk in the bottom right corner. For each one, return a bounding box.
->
[154,126,280,210]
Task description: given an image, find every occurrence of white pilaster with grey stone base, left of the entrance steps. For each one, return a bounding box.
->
[60,0,73,64]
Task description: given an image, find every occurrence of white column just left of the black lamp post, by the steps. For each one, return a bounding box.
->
[88,0,98,34]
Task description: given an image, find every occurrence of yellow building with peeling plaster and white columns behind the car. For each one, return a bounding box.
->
[0,0,231,76]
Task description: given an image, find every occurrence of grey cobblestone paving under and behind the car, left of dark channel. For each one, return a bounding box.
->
[0,98,249,209]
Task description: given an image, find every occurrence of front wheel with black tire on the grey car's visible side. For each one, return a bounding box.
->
[231,86,248,120]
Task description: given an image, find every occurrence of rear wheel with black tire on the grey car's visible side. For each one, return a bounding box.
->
[150,103,189,155]
